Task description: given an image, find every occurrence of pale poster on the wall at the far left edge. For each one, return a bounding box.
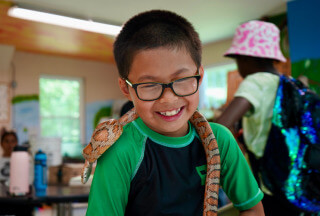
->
[0,83,10,123]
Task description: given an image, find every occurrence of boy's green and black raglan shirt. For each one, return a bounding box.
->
[87,118,263,216]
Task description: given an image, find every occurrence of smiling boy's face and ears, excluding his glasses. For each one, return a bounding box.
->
[119,48,203,137]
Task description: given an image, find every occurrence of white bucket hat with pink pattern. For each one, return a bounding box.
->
[224,20,286,62]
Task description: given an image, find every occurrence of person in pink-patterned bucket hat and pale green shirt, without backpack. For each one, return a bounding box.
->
[216,20,308,216]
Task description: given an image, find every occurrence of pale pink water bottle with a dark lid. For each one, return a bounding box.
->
[9,146,29,196]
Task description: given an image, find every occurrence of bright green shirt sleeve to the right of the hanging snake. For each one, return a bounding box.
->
[211,124,263,211]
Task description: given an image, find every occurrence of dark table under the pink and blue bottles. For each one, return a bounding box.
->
[0,184,90,216]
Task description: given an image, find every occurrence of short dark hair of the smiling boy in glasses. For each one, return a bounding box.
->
[113,10,201,78]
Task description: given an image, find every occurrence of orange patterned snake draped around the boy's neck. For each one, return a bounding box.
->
[81,108,220,216]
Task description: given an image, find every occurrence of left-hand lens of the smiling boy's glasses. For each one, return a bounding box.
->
[137,83,162,100]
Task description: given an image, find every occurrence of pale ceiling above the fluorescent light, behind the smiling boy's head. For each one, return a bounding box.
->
[11,0,288,44]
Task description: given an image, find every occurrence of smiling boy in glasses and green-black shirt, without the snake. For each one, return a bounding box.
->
[87,10,264,216]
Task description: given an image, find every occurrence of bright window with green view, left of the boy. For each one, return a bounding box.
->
[39,76,84,157]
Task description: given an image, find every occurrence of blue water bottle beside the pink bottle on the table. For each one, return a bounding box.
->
[34,150,48,196]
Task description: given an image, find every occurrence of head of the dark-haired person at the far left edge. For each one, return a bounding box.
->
[1,129,18,157]
